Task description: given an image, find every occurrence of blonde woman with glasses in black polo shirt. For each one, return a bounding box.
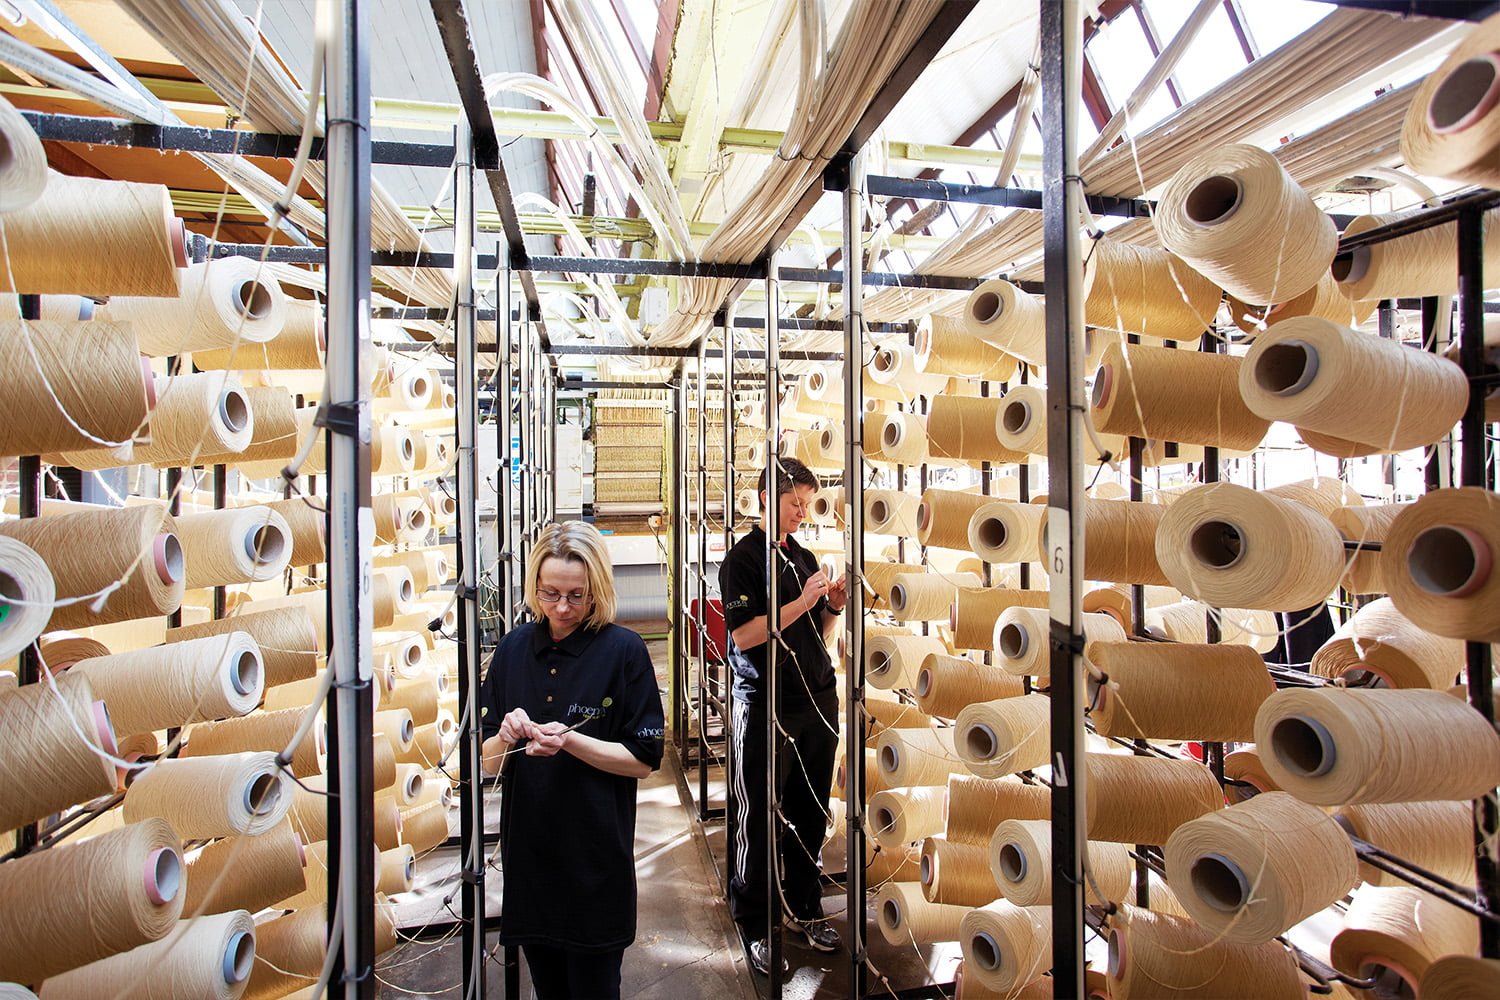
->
[480,522,665,1000]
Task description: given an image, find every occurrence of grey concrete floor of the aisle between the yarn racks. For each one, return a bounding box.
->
[377,640,959,1000]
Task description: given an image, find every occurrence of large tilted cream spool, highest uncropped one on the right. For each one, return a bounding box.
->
[1155,144,1338,301]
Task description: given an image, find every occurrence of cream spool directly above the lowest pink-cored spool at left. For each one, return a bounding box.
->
[125,753,291,840]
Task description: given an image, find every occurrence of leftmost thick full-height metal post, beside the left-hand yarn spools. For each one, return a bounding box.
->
[327,0,375,1000]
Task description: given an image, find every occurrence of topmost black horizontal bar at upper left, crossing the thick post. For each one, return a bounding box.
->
[21,111,453,168]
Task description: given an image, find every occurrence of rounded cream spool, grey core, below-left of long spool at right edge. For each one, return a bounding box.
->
[1166,792,1359,945]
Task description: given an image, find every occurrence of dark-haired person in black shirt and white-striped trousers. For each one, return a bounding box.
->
[719,459,849,975]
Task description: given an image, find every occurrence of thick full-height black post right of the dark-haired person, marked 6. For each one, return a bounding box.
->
[1041,0,1088,997]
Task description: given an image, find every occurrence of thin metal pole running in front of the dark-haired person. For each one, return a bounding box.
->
[761,253,782,1000]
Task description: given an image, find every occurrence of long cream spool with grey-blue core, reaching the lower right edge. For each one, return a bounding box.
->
[1256,688,1500,805]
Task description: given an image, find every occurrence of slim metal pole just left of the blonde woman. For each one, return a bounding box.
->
[453,118,488,997]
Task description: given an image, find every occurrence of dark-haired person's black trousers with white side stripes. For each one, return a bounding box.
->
[729,697,839,940]
